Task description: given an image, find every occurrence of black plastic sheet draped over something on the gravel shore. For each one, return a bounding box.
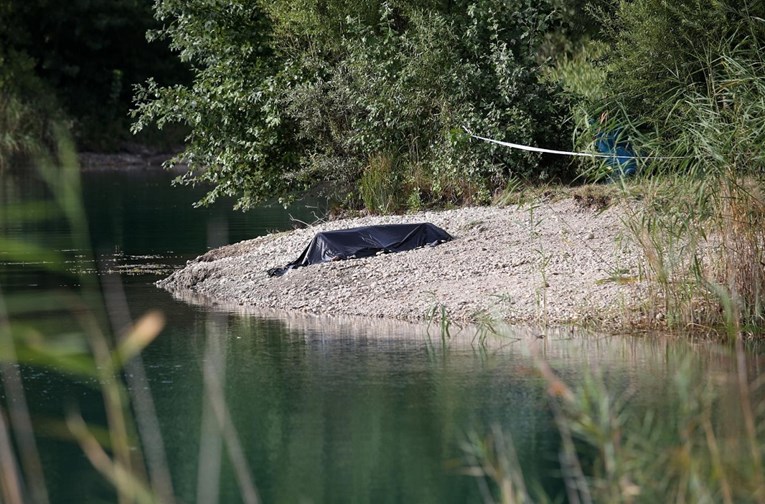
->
[268,222,452,276]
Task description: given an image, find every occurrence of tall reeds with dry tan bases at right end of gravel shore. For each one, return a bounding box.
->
[612,33,765,335]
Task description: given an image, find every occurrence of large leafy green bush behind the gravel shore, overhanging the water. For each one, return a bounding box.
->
[135,0,567,207]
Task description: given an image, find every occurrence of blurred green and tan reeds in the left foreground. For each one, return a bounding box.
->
[0,132,259,504]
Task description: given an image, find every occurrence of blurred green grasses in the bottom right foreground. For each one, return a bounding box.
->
[472,354,765,503]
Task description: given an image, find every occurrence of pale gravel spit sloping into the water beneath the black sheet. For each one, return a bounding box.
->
[157,199,645,325]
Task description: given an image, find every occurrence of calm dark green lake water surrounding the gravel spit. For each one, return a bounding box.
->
[0,164,759,503]
